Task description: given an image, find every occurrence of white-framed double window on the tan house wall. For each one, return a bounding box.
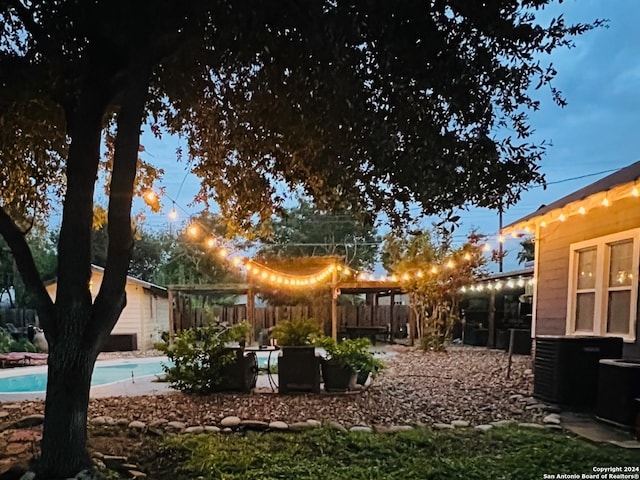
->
[567,228,640,340]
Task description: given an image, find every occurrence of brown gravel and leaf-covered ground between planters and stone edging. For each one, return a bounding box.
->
[0,346,544,427]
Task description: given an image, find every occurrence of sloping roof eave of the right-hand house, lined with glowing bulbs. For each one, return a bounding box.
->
[504,161,640,232]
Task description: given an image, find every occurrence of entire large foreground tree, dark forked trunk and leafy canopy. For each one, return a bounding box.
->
[0,0,602,478]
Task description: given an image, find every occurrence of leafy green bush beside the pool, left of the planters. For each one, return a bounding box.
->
[158,322,248,394]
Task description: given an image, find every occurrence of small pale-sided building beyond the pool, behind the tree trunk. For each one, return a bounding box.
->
[46,265,169,350]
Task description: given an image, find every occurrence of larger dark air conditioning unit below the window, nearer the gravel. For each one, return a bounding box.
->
[533,335,622,407]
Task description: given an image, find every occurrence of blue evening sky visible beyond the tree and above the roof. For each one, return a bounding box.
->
[132,0,640,270]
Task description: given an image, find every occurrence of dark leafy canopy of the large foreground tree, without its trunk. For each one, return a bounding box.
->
[0,0,598,232]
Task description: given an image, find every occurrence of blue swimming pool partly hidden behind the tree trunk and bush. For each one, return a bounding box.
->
[0,352,277,394]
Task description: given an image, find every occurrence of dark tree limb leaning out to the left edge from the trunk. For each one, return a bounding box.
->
[0,204,55,327]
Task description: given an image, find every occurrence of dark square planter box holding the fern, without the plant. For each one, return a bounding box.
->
[278,347,320,393]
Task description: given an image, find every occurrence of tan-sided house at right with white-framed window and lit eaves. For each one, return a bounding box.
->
[503,162,640,358]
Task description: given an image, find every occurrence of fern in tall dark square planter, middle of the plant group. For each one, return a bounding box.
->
[271,318,322,393]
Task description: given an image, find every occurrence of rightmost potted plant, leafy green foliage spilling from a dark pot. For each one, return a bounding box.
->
[316,337,383,392]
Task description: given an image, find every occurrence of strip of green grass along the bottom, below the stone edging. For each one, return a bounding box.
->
[140,427,640,480]
